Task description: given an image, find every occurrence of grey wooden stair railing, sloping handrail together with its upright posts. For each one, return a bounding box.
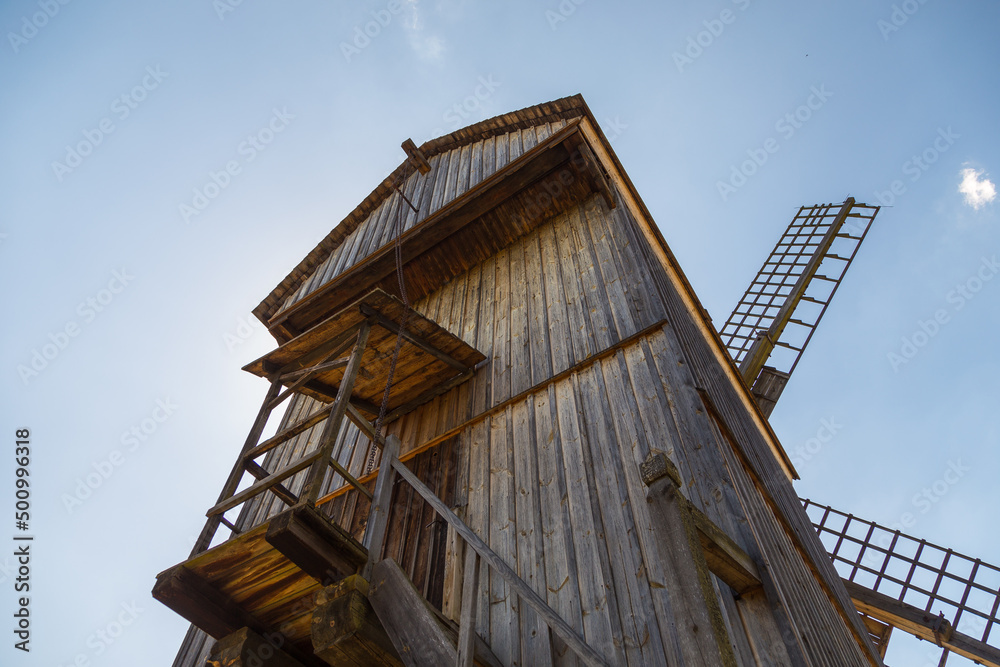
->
[362,435,607,667]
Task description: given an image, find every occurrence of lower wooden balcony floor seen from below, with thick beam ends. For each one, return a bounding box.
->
[153,506,368,665]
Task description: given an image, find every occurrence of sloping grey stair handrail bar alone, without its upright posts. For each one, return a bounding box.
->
[386,456,608,667]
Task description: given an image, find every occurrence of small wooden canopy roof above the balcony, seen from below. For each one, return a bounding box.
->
[243,289,486,415]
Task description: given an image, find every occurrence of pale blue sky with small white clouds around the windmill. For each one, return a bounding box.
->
[0,0,1000,667]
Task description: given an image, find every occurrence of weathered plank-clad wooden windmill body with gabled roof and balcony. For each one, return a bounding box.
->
[153,96,995,667]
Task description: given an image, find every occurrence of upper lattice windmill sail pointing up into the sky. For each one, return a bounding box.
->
[719,198,879,385]
